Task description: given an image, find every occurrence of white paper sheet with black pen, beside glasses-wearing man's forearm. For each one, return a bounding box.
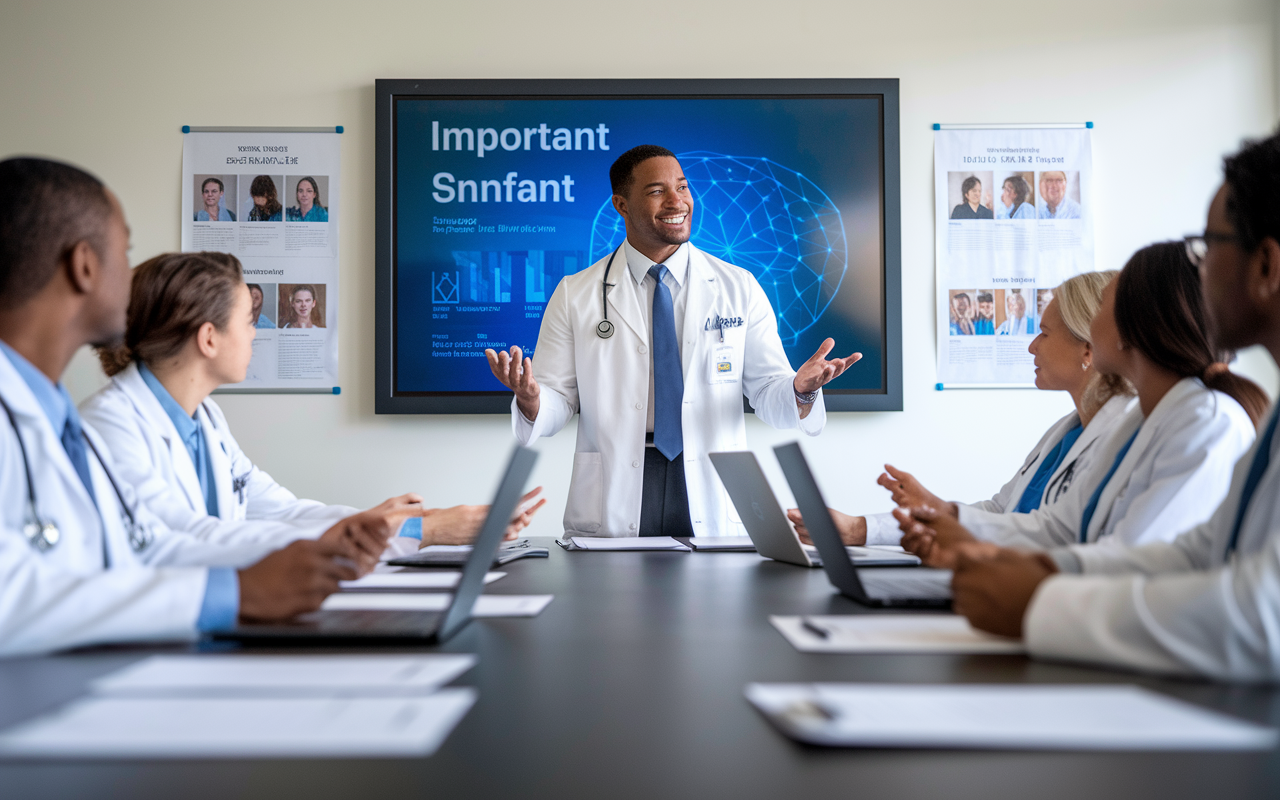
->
[769,614,1027,653]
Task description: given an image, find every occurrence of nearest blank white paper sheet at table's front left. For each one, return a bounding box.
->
[0,689,476,759]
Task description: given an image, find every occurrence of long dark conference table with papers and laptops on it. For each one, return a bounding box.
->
[0,539,1280,800]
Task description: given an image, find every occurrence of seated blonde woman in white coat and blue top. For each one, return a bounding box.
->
[787,271,1137,545]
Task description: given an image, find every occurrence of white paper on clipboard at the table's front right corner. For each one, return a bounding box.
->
[746,684,1276,750]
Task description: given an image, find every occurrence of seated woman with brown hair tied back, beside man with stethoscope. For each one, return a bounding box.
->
[81,252,539,550]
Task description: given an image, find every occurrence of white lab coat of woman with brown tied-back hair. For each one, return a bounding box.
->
[81,364,358,548]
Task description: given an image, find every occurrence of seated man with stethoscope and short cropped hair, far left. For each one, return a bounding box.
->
[0,159,421,655]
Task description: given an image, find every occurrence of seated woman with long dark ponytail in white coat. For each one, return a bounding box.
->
[893,242,1267,567]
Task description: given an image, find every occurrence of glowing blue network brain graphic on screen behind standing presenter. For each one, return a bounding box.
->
[591,152,847,344]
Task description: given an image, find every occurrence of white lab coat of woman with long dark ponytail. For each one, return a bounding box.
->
[961,378,1256,549]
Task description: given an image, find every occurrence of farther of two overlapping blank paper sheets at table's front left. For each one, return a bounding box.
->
[91,654,476,696]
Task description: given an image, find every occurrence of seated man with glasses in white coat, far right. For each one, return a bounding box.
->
[925,136,1280,681]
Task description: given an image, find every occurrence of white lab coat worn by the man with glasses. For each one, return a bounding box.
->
[1023,404,1280,681]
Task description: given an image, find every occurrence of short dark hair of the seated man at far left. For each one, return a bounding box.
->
[0,159,111,308]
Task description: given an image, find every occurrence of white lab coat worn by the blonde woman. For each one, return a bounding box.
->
[867,396,1138,544]
